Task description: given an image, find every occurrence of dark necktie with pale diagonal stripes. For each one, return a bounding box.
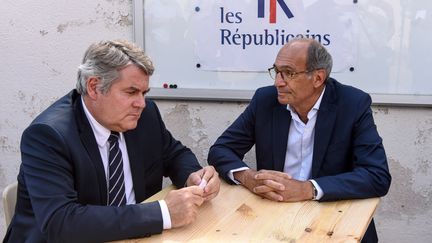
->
[108,132,126,206]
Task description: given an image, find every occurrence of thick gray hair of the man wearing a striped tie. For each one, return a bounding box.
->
[76,40,154,95]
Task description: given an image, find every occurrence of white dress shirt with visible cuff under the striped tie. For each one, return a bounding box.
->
[81,98,171,229]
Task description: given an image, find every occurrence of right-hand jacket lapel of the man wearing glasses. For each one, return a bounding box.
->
[312,79,337,178]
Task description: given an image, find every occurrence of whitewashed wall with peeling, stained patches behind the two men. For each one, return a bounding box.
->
[0,0,432,242]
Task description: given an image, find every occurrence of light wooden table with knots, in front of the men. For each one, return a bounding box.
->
[111,182,380,243]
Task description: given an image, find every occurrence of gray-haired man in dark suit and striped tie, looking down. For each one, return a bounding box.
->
[4,41,220,242]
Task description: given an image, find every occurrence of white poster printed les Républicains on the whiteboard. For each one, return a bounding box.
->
[190,0,357,72]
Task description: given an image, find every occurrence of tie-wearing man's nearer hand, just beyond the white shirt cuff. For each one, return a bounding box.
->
[164,186,204,228]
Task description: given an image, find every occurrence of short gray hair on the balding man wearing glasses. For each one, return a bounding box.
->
[306,40,333,79]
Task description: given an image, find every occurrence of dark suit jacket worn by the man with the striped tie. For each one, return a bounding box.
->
[4,91,201,243]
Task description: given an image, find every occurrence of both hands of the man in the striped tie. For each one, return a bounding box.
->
[164,166,220,228]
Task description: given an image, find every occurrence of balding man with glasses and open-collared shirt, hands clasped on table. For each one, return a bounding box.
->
[208,39,391,242]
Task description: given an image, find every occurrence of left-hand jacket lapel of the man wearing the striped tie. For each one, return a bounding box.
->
[74,96,108,205]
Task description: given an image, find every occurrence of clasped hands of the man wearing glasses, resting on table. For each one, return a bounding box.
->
[234,169,313,202]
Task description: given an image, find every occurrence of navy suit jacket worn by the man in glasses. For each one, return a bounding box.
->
[208,78,391,242]
